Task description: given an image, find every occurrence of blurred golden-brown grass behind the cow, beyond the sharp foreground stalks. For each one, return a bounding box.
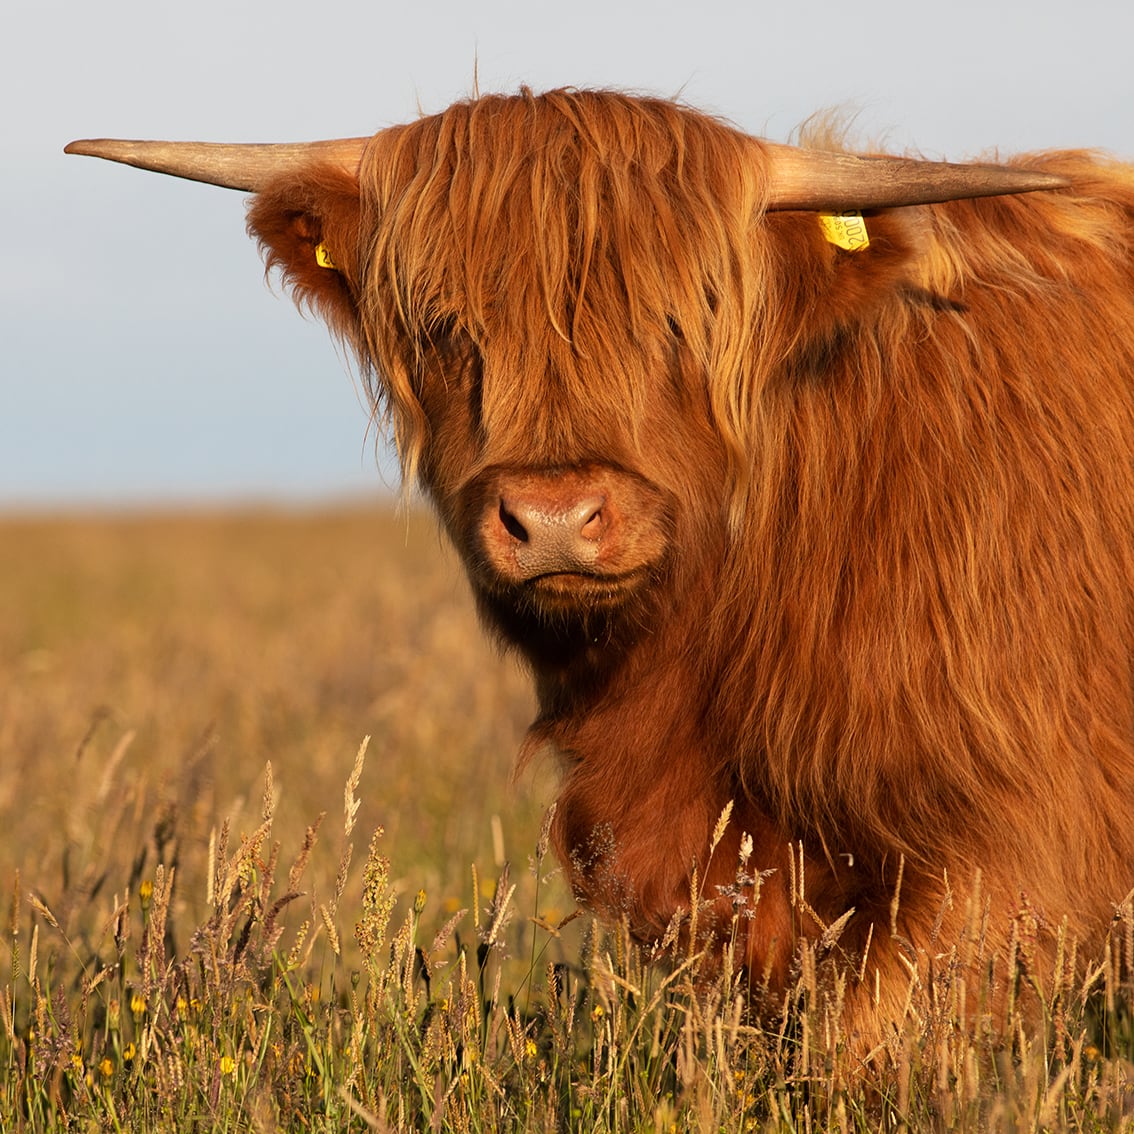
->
[0,502,570,975]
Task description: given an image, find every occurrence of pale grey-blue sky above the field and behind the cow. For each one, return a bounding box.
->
[0,0,1134,511]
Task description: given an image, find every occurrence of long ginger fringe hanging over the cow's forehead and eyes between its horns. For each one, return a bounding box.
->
[351,91,775,489]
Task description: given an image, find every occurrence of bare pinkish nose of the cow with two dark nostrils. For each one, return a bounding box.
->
[499,492,607,575]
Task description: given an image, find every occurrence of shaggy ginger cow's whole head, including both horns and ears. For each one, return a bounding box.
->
[68,91,1059,668]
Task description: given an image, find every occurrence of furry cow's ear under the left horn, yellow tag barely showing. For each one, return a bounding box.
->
[248,166,362,349]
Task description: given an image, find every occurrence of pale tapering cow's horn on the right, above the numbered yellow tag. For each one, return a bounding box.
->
[763,143,1069,212]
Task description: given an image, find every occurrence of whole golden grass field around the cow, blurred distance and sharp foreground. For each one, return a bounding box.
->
[0,505,1134,1131]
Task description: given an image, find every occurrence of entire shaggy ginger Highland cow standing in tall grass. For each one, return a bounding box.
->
[66,91,1134,1041]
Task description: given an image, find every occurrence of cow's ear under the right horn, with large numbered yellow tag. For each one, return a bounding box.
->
[767,210,917,371]
